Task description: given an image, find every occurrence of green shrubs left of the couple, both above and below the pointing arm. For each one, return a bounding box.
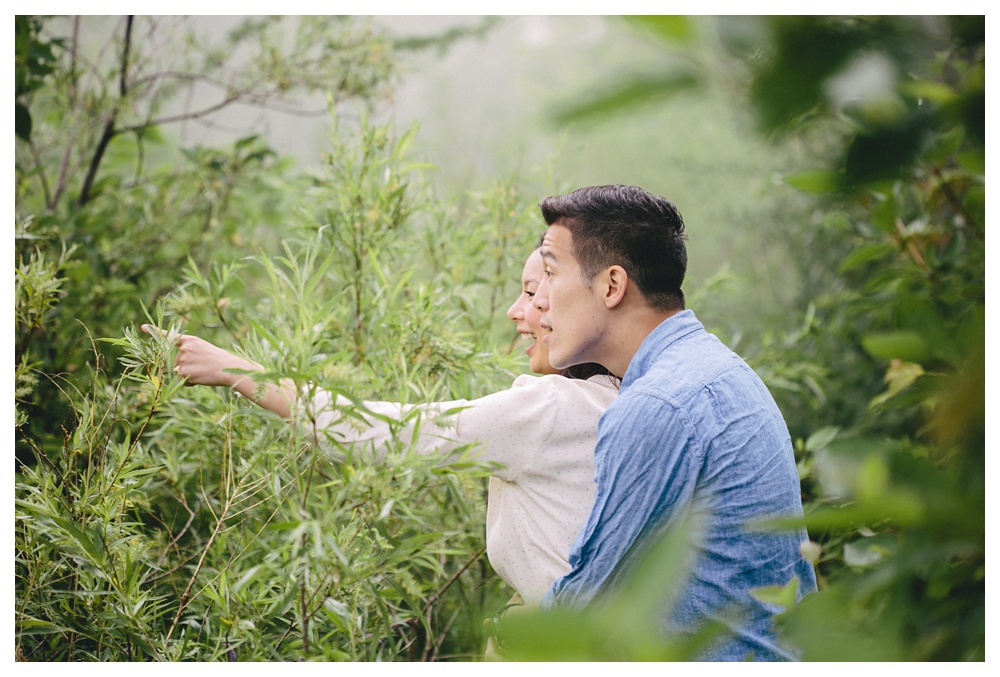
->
[15,18,536,661]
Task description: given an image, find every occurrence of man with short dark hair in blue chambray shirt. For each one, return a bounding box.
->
[534,186,816,660]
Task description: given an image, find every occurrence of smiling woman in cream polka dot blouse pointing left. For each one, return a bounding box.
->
[142,249,618,604]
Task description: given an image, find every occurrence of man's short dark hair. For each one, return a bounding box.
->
[539,185,687,310]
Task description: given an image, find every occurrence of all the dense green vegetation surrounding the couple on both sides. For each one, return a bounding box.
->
[14,16,985,661]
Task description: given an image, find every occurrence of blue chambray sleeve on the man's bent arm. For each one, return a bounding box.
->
[542,393,698,608]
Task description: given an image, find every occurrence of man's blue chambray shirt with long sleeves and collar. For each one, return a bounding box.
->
[542,310,816,661]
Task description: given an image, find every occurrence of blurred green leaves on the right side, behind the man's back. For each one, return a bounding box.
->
[512,16,985,661]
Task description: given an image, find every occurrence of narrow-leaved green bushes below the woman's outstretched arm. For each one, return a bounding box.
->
[15,308,496,661]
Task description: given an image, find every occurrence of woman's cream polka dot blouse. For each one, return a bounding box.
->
[304,375,618,604]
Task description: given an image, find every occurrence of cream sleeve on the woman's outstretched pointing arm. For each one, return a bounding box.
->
[302,375,568,481]
